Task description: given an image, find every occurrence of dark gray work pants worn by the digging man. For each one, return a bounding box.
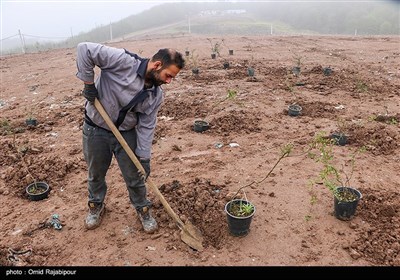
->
[83,122,151,209]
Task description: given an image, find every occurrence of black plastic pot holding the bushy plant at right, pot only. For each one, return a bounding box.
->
[333,187,362,221]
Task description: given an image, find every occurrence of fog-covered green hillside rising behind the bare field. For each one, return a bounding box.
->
[2,1,400,54]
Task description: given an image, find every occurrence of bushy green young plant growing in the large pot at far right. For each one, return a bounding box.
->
[309,133,365,202]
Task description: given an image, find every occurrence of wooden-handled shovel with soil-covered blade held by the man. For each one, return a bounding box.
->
[94,98,203,251]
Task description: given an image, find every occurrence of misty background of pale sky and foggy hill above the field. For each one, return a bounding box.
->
[1,0,400,55]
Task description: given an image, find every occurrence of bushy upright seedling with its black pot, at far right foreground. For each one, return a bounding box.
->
[309,132,365,221]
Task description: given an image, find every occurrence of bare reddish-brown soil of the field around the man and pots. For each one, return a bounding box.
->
[0,36,400,266]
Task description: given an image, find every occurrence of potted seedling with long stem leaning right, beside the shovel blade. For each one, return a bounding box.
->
[225,144,293,236]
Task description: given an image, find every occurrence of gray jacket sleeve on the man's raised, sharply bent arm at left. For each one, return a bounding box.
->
[76,42,126,82]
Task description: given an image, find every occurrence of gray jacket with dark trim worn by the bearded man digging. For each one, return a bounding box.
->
[76,42,164,158]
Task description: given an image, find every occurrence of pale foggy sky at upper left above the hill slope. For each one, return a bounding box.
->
[0,0,163,39]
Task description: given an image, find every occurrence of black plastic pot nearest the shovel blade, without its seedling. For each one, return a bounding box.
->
[225,199,256,236]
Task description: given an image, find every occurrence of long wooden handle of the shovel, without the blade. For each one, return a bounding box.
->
[94,98,184,229]
